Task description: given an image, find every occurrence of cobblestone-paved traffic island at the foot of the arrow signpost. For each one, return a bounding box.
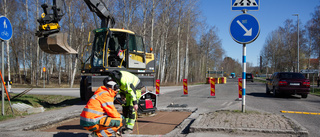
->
[188,110,308,137]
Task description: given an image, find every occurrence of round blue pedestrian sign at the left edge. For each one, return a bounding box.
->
[0,16,12,40]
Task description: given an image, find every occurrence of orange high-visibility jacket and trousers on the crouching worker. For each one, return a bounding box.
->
[80,86,122,127]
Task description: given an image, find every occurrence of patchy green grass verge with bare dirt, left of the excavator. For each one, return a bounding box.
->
[0,94,80,121]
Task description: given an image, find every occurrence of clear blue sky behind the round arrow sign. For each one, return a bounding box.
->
[200,0,320,66]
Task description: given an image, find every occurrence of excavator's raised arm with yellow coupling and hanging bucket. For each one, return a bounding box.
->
[36,0,115,54]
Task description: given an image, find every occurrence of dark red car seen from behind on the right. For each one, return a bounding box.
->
[266,72,310,98]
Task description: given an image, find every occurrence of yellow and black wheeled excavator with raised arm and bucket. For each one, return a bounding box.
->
[36,0,156,113]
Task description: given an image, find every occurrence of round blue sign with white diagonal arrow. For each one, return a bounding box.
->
[230,14,260,44]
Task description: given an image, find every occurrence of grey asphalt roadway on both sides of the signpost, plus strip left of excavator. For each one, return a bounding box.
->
[7,79,320,136]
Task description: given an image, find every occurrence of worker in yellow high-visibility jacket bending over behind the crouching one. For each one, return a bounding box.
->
[110,70,145,134]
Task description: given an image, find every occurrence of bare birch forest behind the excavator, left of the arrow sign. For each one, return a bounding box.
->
[0,0,228,87]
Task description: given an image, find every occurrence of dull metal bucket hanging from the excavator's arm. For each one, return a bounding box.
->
[39,33,78,54]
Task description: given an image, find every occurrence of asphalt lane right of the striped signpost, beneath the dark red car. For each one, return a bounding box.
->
[247,79,320,136]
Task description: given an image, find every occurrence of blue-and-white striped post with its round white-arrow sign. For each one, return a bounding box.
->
[230,7,260,113]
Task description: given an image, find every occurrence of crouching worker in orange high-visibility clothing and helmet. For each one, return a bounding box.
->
[80,76,125,137]
